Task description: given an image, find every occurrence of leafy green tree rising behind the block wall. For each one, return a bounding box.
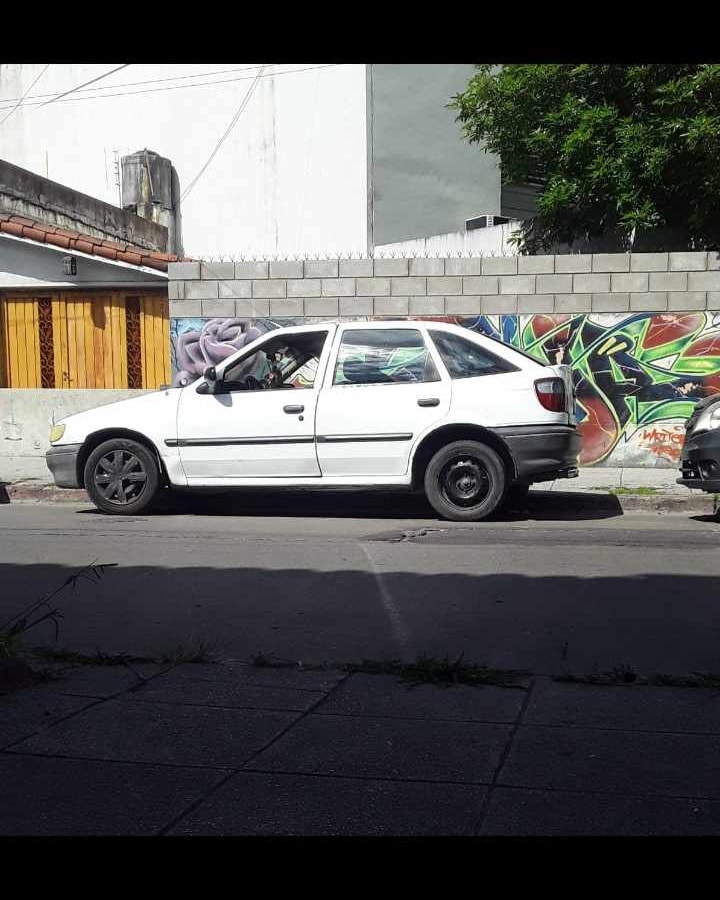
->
[450,64,720,253]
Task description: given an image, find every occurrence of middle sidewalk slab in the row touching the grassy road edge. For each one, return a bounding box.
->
[315,673,525,722]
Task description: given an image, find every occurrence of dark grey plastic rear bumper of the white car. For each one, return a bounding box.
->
[493,425,580,482]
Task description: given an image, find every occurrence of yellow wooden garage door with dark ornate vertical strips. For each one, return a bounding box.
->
[0,293,171,389]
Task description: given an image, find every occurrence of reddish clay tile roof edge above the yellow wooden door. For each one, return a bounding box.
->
[0,212,188,272]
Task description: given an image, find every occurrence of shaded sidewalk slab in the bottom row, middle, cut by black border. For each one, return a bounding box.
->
[170,772,486,835]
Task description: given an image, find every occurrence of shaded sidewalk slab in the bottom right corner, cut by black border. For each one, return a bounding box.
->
[478,788,720,836]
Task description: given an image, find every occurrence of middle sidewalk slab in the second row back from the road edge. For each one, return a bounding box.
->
[248,714,510,784]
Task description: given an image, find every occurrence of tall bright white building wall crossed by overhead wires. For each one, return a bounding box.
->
[0,62,367,257]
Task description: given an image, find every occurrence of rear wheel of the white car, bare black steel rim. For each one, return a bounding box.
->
[424,441,507,522]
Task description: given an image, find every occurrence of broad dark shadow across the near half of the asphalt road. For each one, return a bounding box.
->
[0,564,720,674]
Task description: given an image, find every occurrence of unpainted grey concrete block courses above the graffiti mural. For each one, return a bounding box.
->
[168,252,720,318]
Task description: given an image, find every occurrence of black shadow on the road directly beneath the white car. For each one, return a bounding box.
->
[71,490,623,522]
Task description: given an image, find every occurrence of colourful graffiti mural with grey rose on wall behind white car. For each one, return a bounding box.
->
[171,313,720,468]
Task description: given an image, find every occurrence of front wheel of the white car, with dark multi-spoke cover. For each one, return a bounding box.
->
[83,438,160,516]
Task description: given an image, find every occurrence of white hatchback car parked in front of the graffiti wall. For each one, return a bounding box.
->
[47,320,580,522]
